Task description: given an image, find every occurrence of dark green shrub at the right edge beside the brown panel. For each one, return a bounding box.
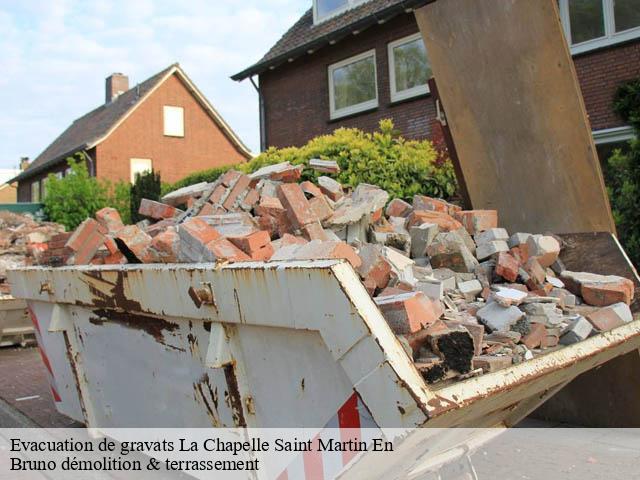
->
[603,79,640,265]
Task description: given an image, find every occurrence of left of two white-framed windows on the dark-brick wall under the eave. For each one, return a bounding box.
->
[329,50,378,119]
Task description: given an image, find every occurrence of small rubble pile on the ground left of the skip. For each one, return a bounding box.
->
[0,210,64,294]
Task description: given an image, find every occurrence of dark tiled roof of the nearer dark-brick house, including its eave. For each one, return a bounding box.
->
[231,0,433,80]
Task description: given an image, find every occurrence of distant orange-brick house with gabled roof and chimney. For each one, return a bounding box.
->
[14,64,251,202]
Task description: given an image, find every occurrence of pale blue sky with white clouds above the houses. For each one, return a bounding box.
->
[0,0,311,168]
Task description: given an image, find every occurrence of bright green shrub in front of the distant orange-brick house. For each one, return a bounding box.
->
[43,153,130,230]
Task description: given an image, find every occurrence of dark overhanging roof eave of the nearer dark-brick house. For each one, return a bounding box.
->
[231,0,436,82]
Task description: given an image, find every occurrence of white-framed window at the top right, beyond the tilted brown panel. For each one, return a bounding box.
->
[559,0,640,53]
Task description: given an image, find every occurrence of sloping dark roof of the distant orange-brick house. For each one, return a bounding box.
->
[14,65,175,180]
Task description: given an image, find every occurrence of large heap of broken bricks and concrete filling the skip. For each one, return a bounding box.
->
[35,161,634,383]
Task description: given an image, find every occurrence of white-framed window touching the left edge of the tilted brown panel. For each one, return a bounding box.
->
[388,33,431,102]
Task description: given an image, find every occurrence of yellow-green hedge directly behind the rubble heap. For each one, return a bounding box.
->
[165,120,456,200]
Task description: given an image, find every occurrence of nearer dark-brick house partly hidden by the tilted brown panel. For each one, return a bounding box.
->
[232,0,640,161]
